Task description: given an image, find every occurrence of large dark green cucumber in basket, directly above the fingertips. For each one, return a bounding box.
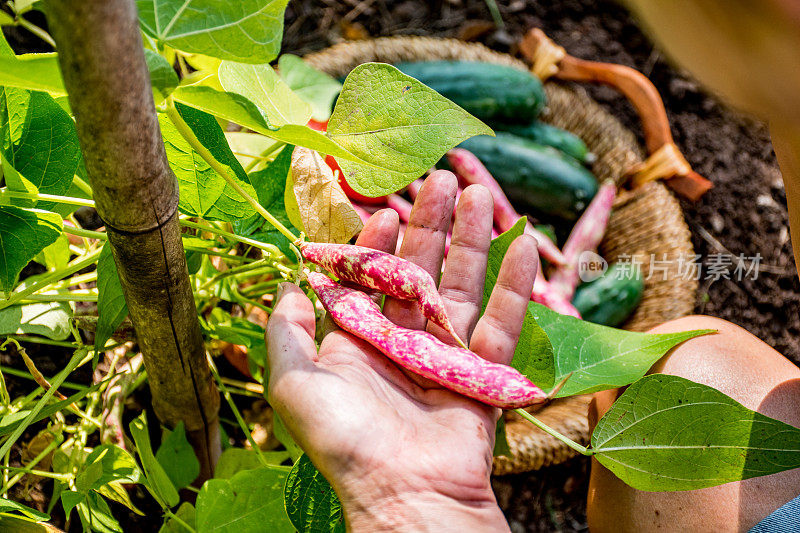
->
[460,132,597,220]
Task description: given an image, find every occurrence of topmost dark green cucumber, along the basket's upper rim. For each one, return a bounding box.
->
[397,61,545,124]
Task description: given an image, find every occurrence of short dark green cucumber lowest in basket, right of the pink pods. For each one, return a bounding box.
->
[572,263,644,327]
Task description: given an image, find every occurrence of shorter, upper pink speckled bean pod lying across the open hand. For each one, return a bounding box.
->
[297,242,465,346]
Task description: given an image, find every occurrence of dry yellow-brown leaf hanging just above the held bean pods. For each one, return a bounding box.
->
[292,147,363,243]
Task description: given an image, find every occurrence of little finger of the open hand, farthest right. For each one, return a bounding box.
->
[470,235,539,364]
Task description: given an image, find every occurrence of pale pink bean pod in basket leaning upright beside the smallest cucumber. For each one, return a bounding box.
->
[550,180,617,299]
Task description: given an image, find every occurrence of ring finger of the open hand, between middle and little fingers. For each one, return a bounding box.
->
[428,185,494,342]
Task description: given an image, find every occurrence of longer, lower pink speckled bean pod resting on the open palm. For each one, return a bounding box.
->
[308,272,547,409]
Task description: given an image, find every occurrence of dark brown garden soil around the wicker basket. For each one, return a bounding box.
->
[284,0,800,532]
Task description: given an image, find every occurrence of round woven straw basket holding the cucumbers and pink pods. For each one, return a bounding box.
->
[305,37,697,474]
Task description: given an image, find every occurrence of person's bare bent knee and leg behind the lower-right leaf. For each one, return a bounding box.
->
[587,316,800,533]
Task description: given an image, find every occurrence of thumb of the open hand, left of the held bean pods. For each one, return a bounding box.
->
[266,283,317,381]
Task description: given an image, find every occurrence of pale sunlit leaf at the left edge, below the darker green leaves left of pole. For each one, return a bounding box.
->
[0,302,72,341]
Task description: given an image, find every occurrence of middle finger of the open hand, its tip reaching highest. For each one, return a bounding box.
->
[383,170,458,329]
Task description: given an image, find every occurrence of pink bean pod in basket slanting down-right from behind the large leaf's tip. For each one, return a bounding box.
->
[447,148,566,265]
